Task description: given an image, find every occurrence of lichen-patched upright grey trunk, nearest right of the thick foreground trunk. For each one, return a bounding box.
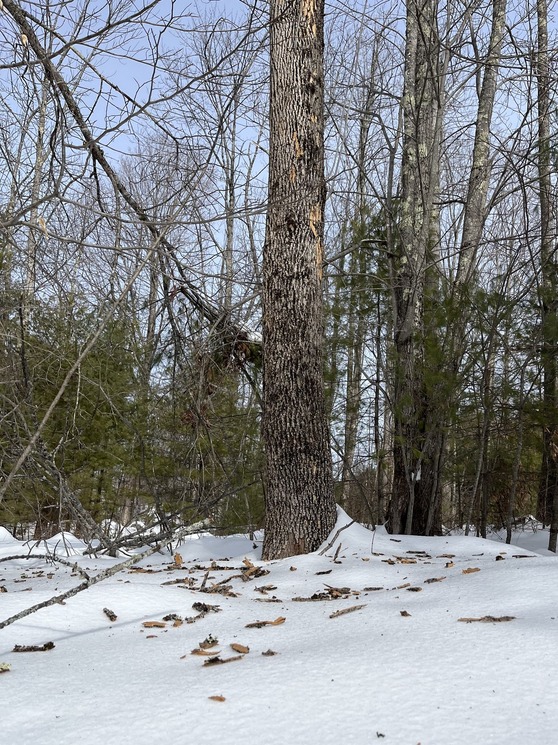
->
[389,0,441,533]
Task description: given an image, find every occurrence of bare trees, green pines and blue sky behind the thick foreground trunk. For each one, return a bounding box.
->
[0,0,558,538]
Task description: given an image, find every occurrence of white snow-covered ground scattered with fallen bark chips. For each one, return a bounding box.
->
[0,511,558,745]
